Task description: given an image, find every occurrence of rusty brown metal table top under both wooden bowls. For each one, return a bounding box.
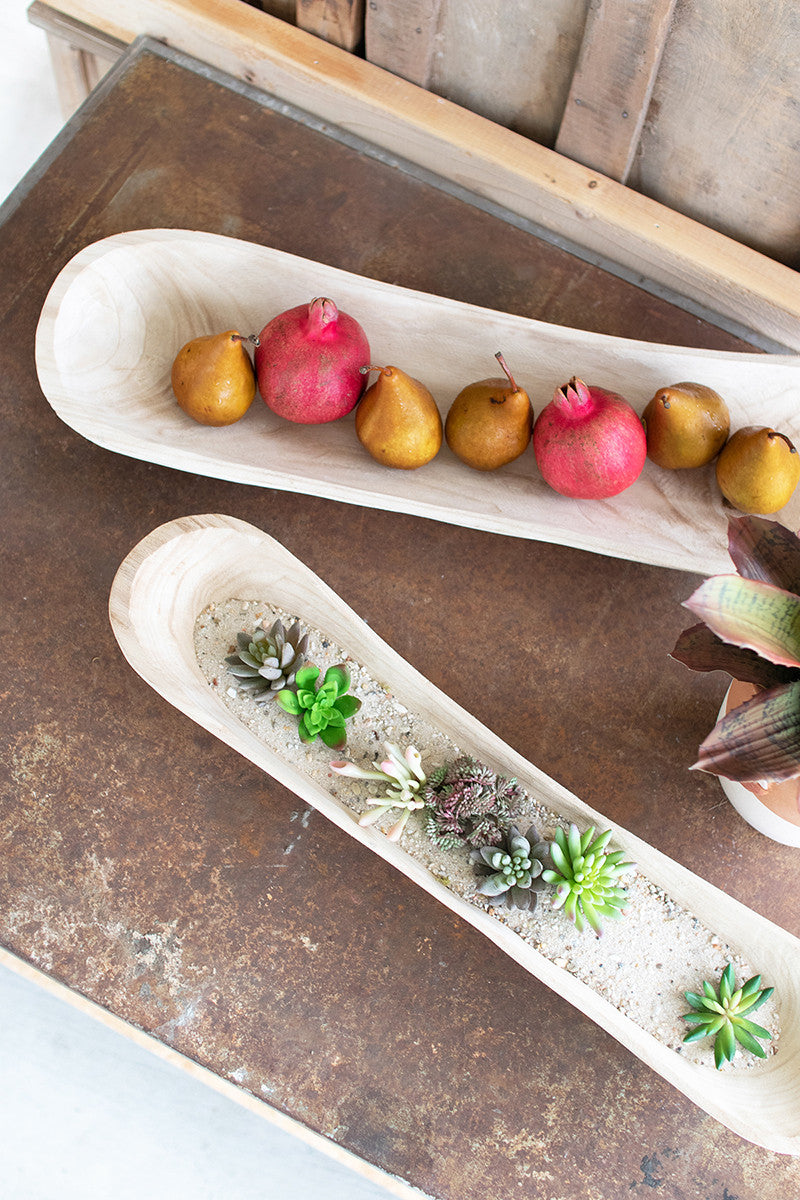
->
[0,35,800,1200]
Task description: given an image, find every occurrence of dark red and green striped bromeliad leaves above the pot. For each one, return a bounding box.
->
[672,516,800,782]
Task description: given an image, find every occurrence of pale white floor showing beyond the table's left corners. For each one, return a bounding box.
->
[0,0,407,1200]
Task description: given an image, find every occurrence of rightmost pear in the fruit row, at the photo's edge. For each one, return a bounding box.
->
[716,425,800,516]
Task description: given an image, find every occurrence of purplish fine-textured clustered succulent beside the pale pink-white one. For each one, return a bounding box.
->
[422,755,523,850]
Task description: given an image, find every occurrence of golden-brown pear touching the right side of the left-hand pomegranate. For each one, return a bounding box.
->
[355,367,441,470]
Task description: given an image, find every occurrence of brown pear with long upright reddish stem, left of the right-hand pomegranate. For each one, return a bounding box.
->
[445,352,534,470]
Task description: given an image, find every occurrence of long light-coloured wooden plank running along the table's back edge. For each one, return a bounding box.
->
[38,0,800,350]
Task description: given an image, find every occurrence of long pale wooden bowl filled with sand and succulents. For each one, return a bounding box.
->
[109,515,800,1154]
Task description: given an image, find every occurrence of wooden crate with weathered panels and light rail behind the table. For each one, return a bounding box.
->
[28,0,800,349]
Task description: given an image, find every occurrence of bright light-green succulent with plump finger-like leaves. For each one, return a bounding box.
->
[542,824,633,934]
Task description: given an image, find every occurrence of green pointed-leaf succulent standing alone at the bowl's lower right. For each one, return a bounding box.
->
[682,962,775,1070]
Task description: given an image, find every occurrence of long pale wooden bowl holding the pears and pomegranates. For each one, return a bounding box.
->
[36,229,800,574]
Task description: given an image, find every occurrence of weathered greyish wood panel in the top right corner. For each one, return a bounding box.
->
[630,0,800,269]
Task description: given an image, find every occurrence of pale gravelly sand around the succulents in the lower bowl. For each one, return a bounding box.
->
[196,599,780,1070]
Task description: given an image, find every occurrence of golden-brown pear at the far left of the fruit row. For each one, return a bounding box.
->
[172,329,255,425]
